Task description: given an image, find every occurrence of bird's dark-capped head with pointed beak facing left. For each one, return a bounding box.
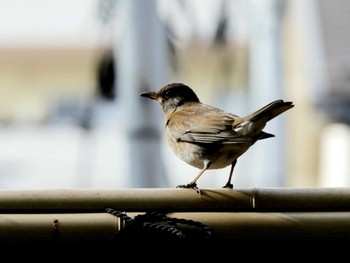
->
[140,83,199,113]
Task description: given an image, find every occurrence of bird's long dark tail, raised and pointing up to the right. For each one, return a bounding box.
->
[245,100,294,122]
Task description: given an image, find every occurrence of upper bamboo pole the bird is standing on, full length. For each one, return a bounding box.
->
[0,188,350,213]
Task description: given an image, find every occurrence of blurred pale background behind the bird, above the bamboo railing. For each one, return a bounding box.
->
[0,0,350,189]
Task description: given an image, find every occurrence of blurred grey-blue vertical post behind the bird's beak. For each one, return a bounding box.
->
[115,0,167,187]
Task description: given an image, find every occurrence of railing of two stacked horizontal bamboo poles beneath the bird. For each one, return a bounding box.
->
[0,188,350,245]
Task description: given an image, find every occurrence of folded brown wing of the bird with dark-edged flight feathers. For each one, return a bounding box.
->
[166,104,253,144]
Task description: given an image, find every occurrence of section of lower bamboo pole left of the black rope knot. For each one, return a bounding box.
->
[0,213,119,245]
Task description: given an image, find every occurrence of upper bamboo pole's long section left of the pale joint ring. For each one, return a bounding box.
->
[0,188,253,212]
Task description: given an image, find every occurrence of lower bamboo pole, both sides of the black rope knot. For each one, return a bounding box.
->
[0,212,350,245]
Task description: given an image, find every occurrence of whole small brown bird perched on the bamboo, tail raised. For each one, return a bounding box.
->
[140,83,294,191]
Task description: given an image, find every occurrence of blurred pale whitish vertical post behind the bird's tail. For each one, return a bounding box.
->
[249,0,285,187]
